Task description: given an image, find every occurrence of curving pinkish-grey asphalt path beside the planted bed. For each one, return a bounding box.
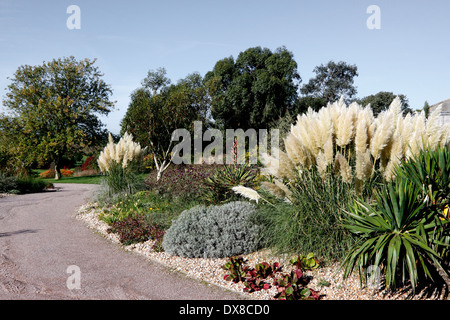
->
[0,184,242,300]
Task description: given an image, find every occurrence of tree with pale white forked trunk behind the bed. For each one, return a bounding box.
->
[121,69,208,180]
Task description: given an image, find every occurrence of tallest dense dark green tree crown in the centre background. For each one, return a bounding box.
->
[205,47,301,130]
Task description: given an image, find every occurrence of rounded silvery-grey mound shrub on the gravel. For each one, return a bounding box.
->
[162,201,260,258]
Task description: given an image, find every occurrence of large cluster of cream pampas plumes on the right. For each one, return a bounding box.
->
[263,97,450,198]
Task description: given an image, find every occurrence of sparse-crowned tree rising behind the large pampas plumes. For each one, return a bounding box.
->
[300,61,358,103]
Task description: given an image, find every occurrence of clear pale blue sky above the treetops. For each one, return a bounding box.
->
[0,0,450,133]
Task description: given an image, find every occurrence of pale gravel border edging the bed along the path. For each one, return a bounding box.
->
[76,203,448,300]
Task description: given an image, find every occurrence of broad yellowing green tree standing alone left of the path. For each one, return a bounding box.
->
[2,57,113,179]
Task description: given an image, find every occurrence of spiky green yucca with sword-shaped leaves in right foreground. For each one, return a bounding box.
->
[342,177,447,292]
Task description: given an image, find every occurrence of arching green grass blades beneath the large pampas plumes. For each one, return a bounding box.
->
[257,168,354,263]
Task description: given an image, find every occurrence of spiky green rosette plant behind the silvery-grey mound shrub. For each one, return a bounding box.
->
[201,164,258,204]
